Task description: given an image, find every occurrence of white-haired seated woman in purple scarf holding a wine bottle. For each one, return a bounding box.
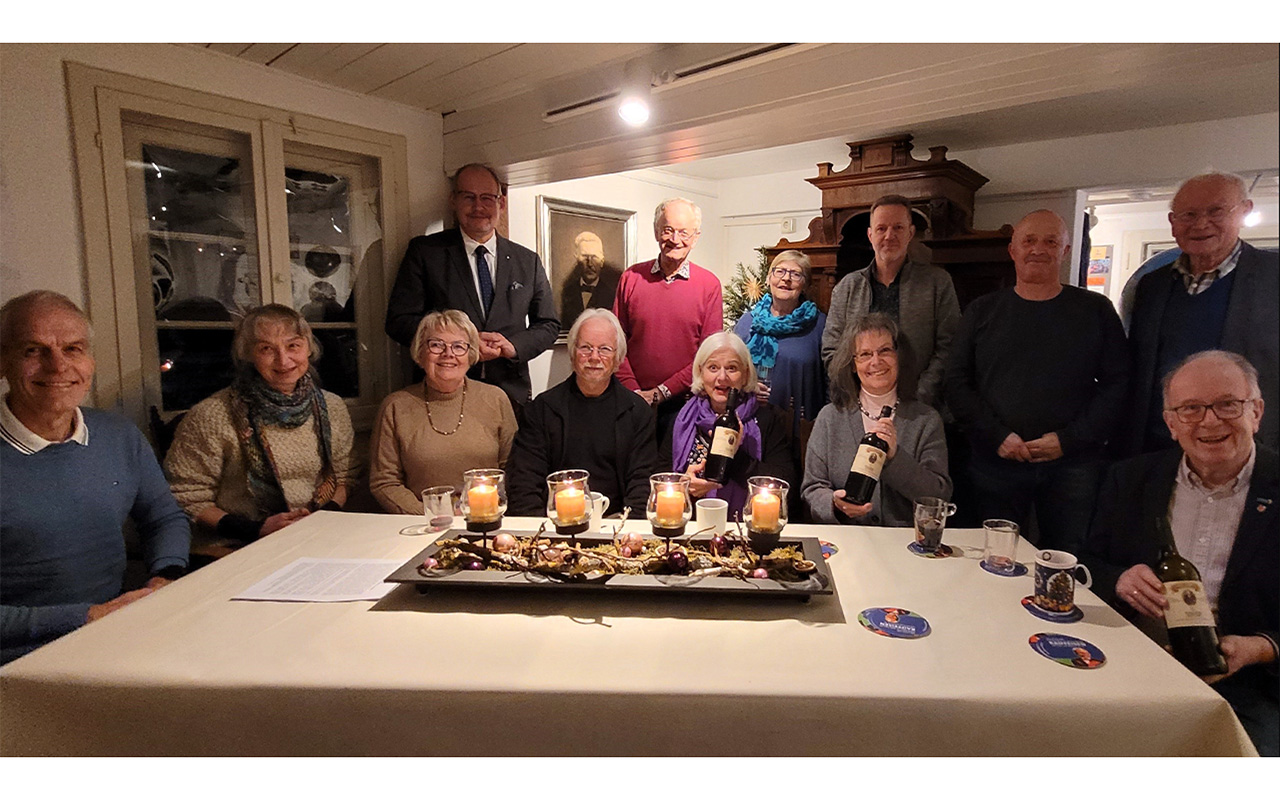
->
[659,332,797,518]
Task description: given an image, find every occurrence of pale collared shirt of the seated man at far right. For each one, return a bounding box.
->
[1169,447,1257,608]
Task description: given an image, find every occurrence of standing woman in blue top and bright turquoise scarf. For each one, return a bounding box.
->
[733,250,827,434]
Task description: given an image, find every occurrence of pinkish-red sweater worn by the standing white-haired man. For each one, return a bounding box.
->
[613,261,724,394]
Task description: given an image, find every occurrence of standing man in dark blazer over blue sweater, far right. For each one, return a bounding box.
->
[1116,173,1280,456]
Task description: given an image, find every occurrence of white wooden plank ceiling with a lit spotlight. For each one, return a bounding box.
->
[197,44,1280,184]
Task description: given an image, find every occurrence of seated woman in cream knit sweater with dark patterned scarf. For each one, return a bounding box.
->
[165,303,356,554]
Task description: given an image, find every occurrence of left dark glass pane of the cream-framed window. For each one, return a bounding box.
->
[124,116,262,412]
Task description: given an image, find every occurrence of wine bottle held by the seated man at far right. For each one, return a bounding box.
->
[1156,517,1226,675]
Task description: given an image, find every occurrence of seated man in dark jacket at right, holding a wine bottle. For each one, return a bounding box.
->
[1083,351,1280,755]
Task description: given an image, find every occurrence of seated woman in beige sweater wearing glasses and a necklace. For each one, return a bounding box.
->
[369,310,516,515]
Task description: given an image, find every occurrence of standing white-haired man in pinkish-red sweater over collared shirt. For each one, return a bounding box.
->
[613,197,724,440]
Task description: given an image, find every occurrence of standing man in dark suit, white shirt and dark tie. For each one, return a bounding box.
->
[387,164,559,410]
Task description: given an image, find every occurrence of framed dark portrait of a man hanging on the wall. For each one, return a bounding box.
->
[535,195,636,344]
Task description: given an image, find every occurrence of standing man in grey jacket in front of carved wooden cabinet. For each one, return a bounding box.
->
[822,195,960,408]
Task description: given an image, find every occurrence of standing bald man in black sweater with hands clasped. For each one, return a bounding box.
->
[946,210,1129,553]
